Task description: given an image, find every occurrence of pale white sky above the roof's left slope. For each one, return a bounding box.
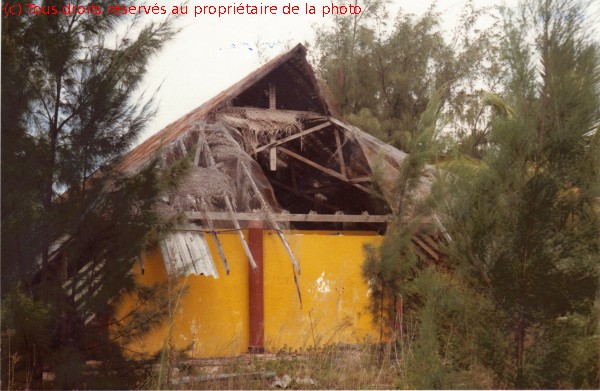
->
[137,0,600,144]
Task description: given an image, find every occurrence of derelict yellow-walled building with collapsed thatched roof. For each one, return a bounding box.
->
[122,45,440,357]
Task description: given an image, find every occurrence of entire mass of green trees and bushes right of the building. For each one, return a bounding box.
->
[318,0,600,388]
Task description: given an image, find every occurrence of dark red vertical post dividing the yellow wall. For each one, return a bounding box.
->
[248,221,265,353]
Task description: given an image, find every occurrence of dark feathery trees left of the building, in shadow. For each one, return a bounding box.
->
[2,1,183,389]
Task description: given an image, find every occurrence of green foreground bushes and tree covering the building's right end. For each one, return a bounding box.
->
[363,0,600,388]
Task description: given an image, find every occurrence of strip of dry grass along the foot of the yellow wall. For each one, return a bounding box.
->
[163,345,400,390]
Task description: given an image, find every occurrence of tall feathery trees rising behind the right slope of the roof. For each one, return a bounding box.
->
[316,0,505,157]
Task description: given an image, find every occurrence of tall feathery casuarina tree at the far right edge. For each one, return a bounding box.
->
[446,0,600,388]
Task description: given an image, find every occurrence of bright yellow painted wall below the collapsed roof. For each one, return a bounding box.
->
[127,230,382,357]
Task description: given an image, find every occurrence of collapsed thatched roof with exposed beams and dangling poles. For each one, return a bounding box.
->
[122,45,440,274]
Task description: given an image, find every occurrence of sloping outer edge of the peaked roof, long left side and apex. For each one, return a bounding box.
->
[120,44,335,173]
